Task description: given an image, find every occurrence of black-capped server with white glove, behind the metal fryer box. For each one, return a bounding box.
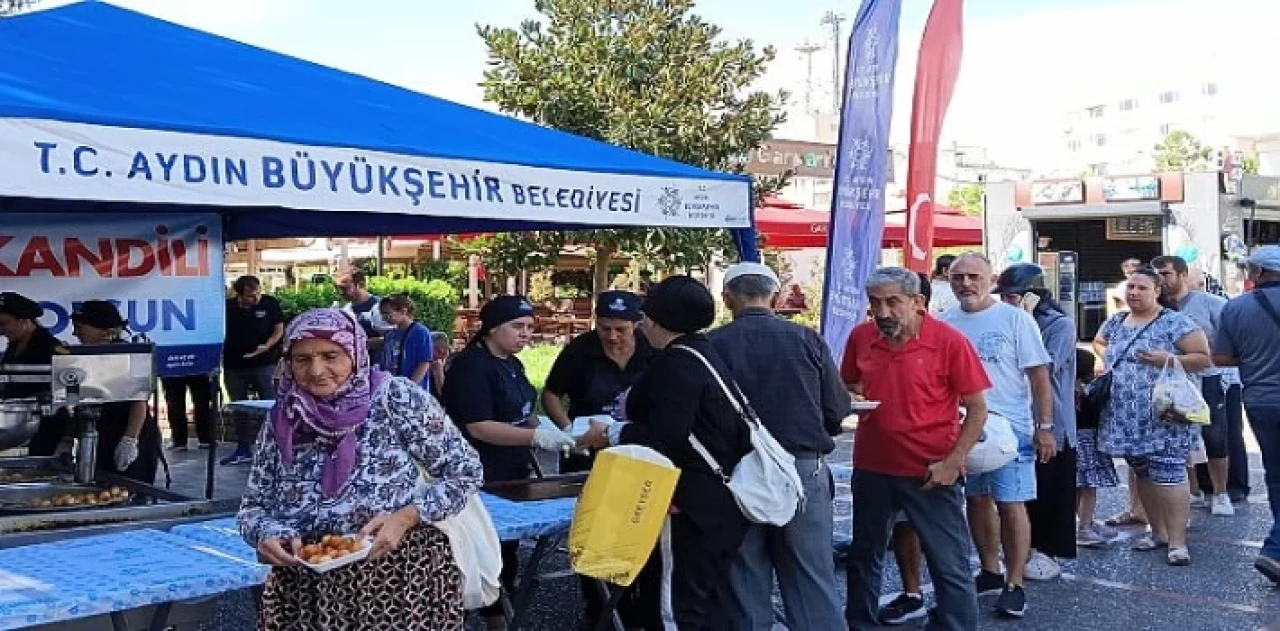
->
[72,301,160,484]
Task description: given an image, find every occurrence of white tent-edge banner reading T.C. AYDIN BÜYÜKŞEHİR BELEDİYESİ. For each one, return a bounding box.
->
[0,119,751,228]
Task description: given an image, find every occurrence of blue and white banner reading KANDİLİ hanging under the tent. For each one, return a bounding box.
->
[0,212,227,376]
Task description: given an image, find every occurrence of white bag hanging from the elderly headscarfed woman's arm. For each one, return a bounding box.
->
[381,381,502,611]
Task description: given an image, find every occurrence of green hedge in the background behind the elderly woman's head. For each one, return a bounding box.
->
[275,276,461,333]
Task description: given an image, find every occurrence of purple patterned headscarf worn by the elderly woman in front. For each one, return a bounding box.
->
[271,308,388,497]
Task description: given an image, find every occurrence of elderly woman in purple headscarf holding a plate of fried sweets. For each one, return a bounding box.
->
[239,308,481,631]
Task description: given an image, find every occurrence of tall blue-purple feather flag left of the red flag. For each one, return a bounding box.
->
[822,0,901,365]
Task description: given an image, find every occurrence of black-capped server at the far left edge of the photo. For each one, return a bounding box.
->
[0,292,69,456]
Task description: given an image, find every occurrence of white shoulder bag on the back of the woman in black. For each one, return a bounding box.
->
[673,344,805,526]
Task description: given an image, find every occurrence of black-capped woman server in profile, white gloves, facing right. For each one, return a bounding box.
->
[440,296,575,628]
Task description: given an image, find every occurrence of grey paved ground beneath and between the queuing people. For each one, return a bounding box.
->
[170,436,1280,631]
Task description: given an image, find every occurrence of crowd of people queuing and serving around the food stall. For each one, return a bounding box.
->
[24,246,1264,630]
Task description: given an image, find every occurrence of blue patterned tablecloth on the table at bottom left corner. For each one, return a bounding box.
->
[0,530,266,630]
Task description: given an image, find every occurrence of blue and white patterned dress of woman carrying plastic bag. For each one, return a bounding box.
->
[1098,308,1201,457]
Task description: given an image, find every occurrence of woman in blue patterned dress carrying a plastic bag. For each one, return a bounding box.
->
[1093,268,1212,566]
